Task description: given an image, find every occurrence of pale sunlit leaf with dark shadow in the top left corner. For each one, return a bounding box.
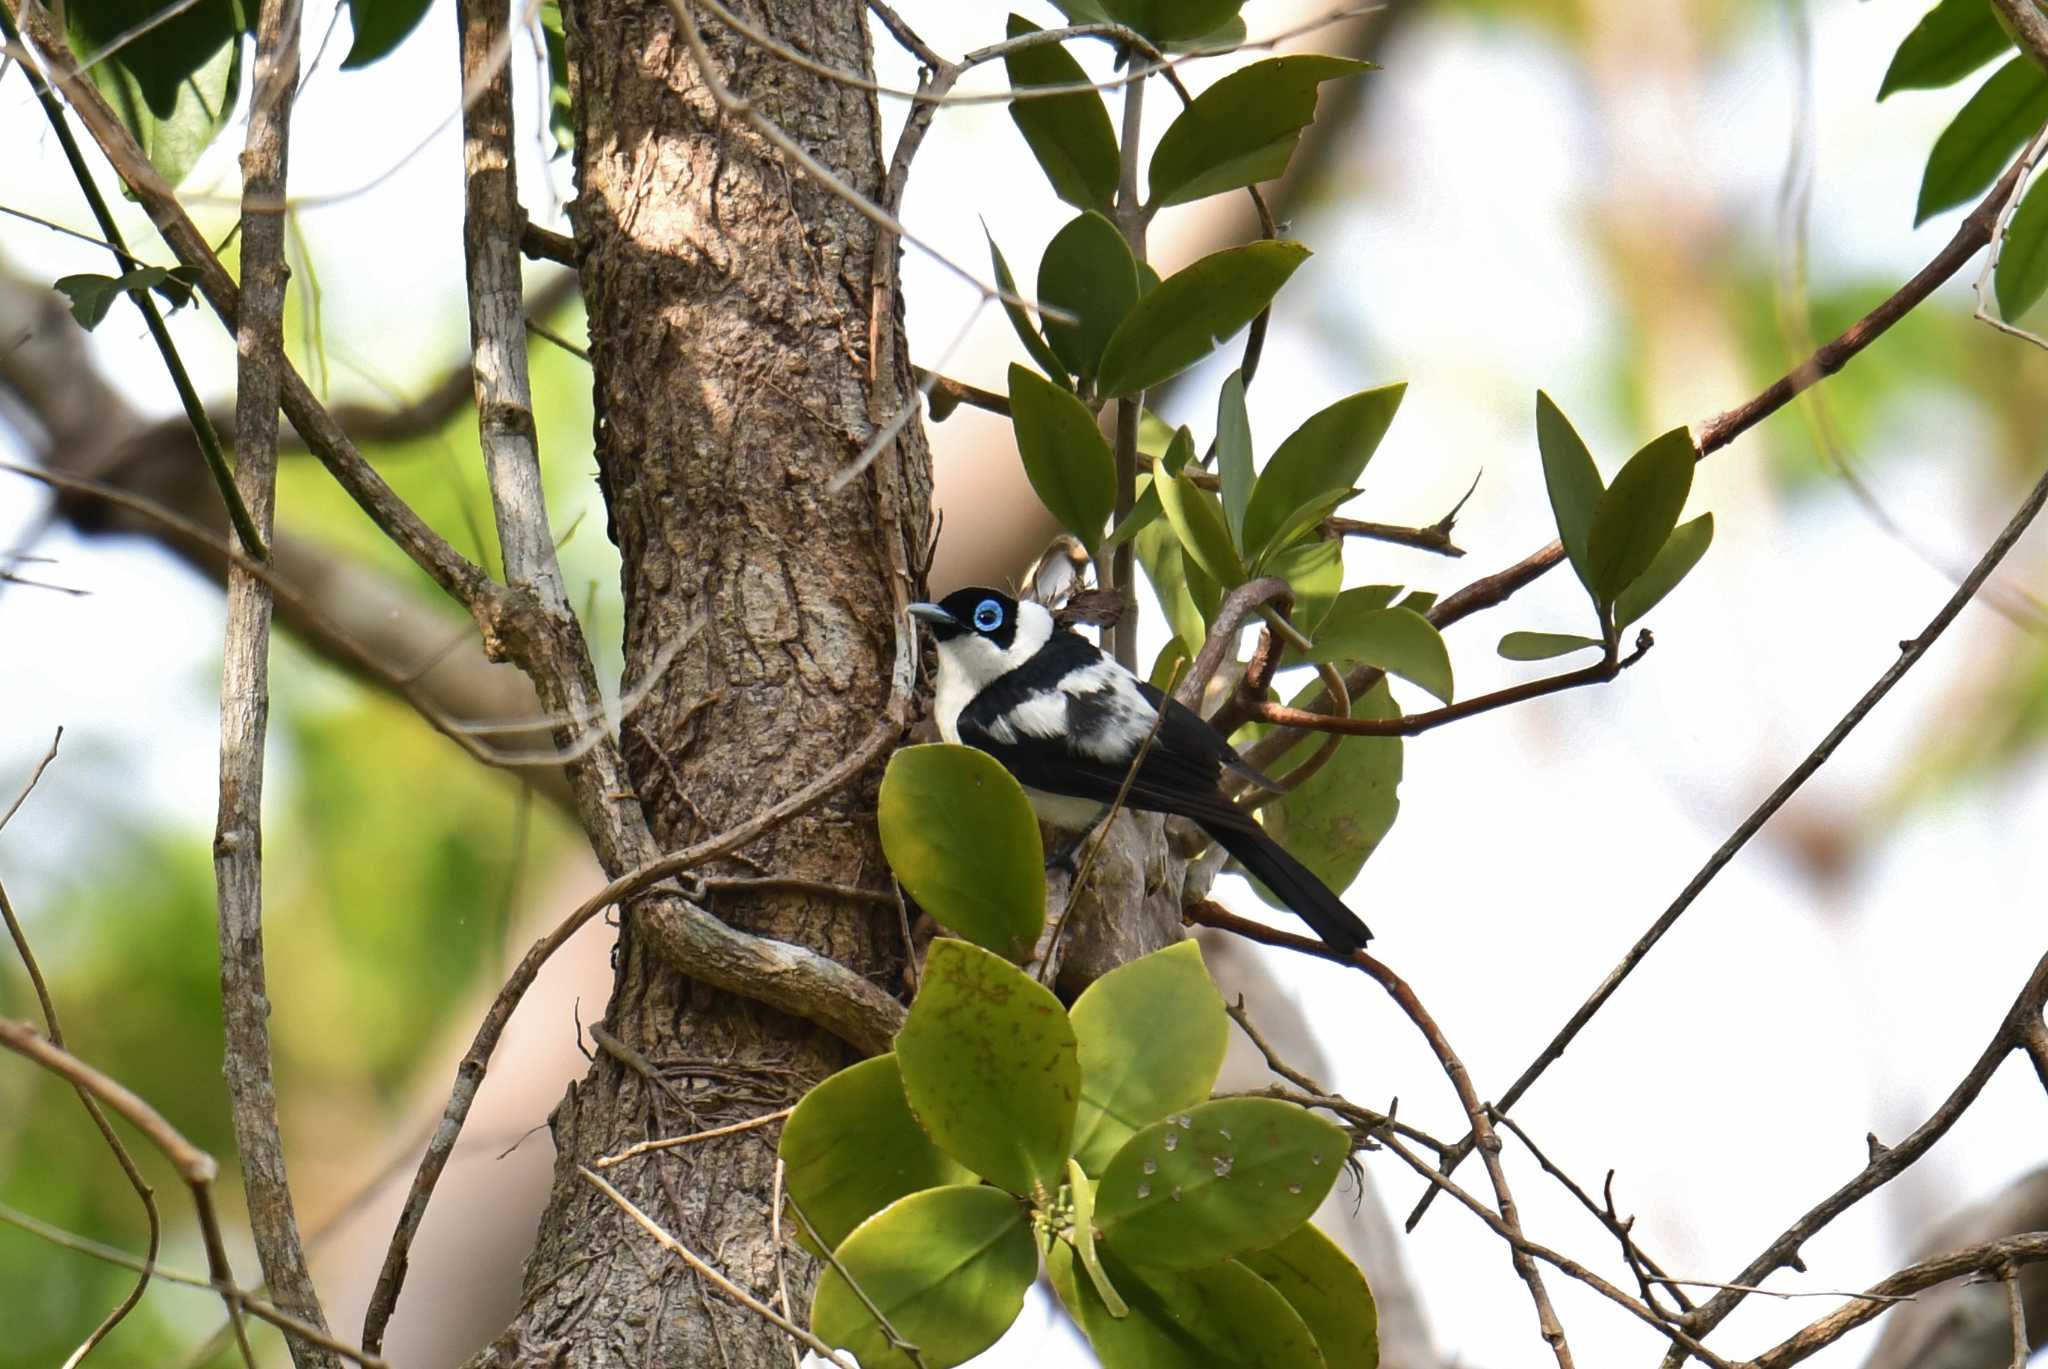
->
[61,0,241,186]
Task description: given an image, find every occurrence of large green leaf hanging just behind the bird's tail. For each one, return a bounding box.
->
[1253,680,1401,908]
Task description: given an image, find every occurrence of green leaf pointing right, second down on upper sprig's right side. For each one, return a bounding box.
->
[1096,242,1309,400]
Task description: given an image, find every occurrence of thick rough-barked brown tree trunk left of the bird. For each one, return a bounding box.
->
[471,0,930,1367]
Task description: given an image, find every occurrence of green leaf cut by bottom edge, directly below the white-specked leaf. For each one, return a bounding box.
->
[1056,1242,1327,1369]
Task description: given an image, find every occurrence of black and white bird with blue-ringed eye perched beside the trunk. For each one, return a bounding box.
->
[909,588,1372,951]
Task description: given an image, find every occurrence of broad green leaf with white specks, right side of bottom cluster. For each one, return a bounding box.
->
[1096,1098,1350,1269]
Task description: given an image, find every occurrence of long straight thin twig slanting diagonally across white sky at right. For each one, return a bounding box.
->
[1407,448,2048,1229]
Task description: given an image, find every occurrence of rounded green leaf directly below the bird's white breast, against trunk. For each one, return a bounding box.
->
[874,744,1044,959]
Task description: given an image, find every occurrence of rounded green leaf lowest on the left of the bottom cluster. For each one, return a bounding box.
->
[811,1185,1038,1369]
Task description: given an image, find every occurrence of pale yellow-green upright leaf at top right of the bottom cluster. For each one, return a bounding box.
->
[1069,941,1231,1174]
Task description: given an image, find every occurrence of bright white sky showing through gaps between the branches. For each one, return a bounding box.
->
[0,0,2048,1367]
